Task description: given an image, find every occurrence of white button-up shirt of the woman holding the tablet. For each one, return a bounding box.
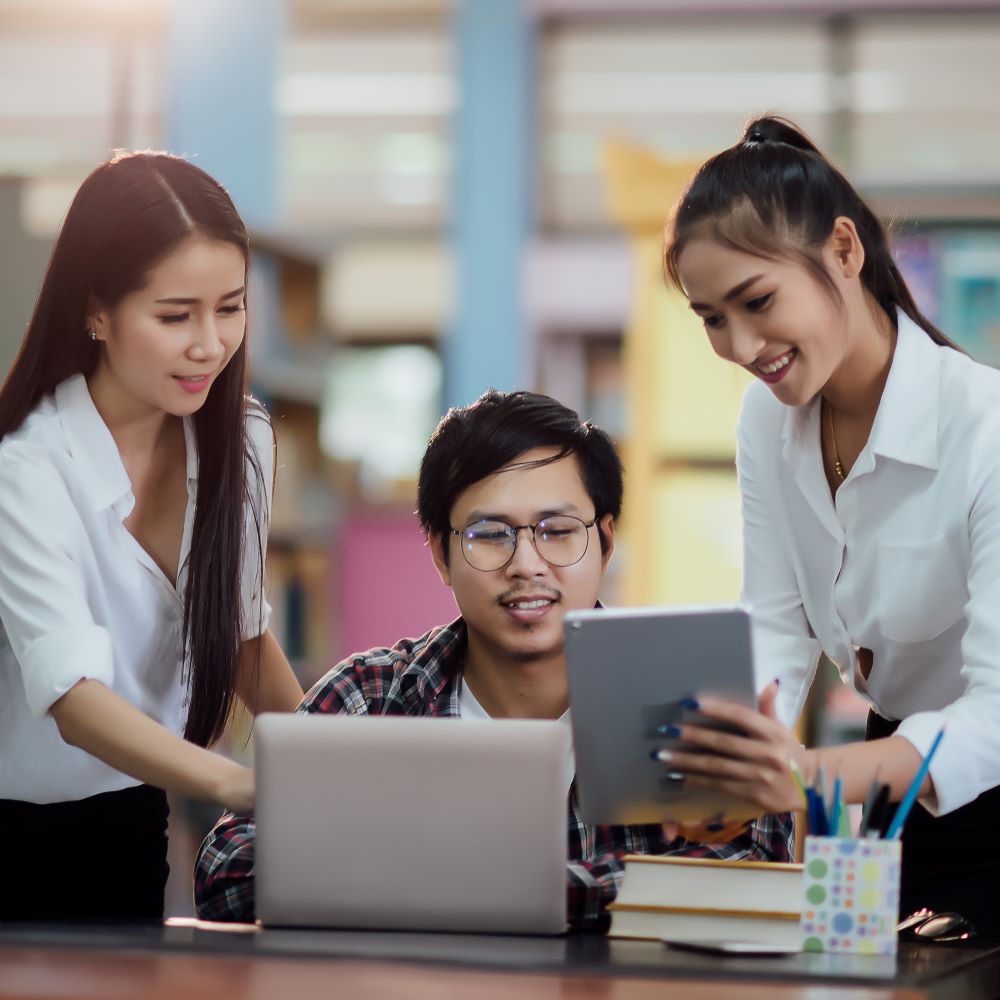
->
[737,314,1000,813]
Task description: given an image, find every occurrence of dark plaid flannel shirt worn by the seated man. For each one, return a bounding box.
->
[194,618,793,928]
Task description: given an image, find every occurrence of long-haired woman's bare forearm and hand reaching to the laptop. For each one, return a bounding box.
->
[50,679,252,805]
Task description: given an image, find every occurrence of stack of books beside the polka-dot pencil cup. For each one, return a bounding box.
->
[608,854,803,947]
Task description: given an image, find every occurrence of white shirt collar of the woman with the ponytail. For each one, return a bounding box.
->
[782,312,942,469]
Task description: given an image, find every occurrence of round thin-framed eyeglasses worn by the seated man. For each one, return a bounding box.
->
[451,514,597,573]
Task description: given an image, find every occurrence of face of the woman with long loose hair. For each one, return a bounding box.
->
[87,236,246,416]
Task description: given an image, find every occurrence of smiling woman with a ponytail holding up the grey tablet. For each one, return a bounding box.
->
[665,117,1000,934]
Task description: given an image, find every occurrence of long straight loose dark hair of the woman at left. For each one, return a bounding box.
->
[0,153,264,746]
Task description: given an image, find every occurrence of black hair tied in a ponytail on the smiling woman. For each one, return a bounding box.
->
[664,116,960,350]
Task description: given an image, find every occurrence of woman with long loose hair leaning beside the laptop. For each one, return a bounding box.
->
[0,153,302,920]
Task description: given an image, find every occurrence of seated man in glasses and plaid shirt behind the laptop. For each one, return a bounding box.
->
[195,390,792,927]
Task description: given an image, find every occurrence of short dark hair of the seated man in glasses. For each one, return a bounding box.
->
[417,389,623,558]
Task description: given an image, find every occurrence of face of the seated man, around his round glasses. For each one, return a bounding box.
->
[431,448,614,663]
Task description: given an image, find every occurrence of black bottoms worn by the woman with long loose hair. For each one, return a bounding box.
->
[0,785,169,923]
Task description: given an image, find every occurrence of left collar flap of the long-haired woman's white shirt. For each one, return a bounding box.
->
[55,374,132,511]
